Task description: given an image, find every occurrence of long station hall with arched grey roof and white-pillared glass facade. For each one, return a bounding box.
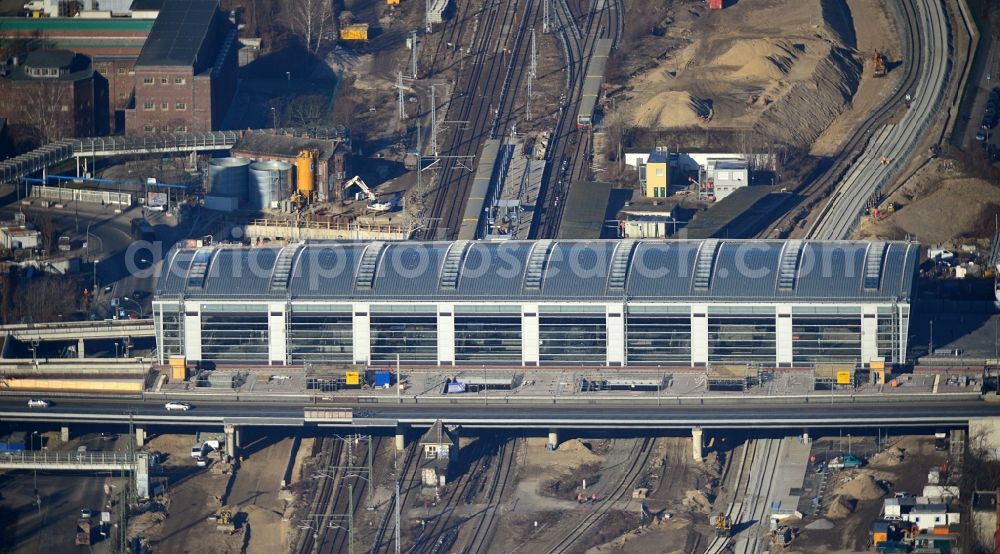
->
[153,239,919,367]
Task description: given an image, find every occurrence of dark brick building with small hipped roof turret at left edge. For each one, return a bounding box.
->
[0,50,97,143]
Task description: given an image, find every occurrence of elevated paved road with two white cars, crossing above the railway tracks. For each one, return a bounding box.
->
[0,398,1000,428]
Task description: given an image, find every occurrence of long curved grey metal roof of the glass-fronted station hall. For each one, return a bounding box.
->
[156,240,919,302]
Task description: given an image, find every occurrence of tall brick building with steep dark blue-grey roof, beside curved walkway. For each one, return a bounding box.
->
[125,0,239,134]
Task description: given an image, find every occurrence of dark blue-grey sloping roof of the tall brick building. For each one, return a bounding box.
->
[135,0,219,67]
